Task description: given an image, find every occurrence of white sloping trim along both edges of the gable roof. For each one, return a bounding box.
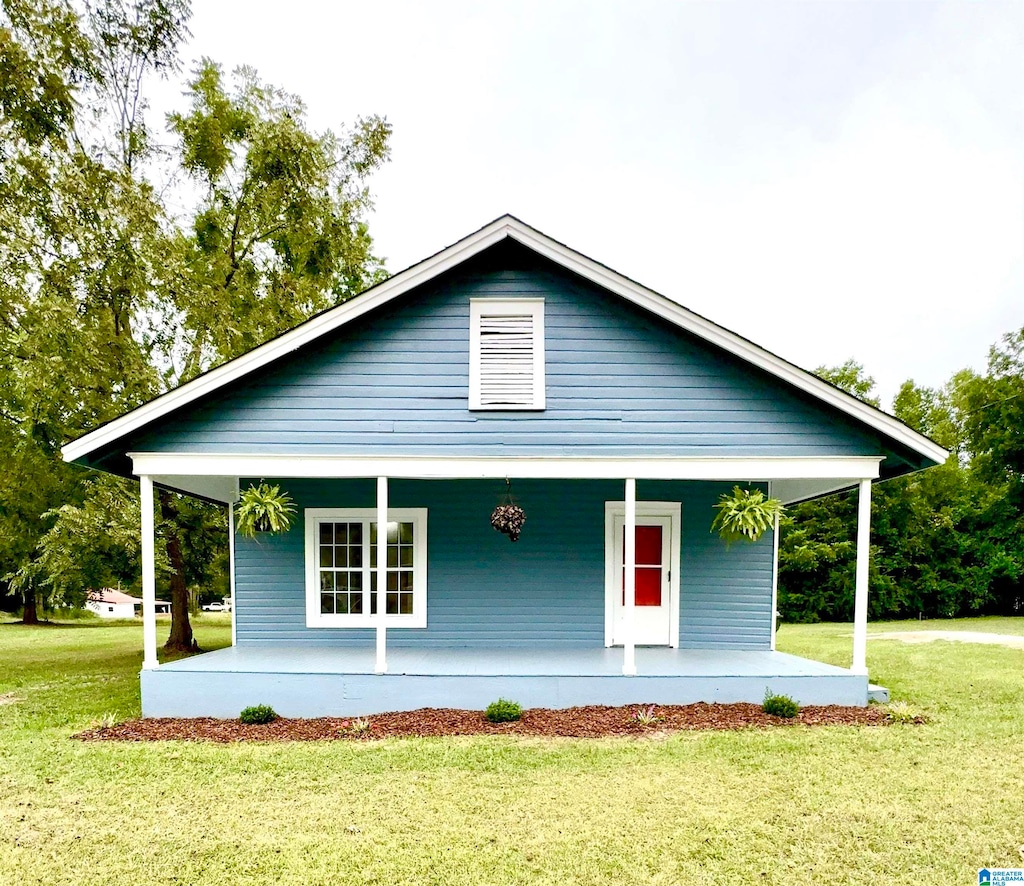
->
[61,215,948,463]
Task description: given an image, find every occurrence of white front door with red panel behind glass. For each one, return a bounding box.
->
[611,514,673,646]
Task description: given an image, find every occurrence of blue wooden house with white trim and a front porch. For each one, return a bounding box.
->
[63,216,946,716]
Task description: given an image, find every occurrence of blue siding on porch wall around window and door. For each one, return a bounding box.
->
[236,479,772,649]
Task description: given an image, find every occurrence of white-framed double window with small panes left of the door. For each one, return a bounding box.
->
[306,508,427,628]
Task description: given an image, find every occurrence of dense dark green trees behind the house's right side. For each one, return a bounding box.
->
[779,346,1024,621]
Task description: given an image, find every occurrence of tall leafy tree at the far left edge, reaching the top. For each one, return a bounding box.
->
[0,0,189,622]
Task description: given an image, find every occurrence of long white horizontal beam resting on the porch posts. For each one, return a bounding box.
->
[128,453,882,481]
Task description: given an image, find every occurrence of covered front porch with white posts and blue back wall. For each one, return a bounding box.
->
[132,454,880,717]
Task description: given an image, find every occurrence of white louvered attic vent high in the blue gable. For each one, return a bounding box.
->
[469,298,544,410]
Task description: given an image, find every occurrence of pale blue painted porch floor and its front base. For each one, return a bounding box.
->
[142,645,867,717]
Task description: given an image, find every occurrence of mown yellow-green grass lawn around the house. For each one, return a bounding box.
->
[0,614,1024,886]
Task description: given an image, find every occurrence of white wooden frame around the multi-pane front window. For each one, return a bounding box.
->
[305,508,427,628]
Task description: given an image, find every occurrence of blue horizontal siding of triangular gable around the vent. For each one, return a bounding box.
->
[134,248,886,456]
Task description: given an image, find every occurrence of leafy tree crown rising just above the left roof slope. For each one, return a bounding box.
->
[165,59,391,380]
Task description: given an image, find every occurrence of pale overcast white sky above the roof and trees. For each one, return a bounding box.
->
[154,0,1024,406]
